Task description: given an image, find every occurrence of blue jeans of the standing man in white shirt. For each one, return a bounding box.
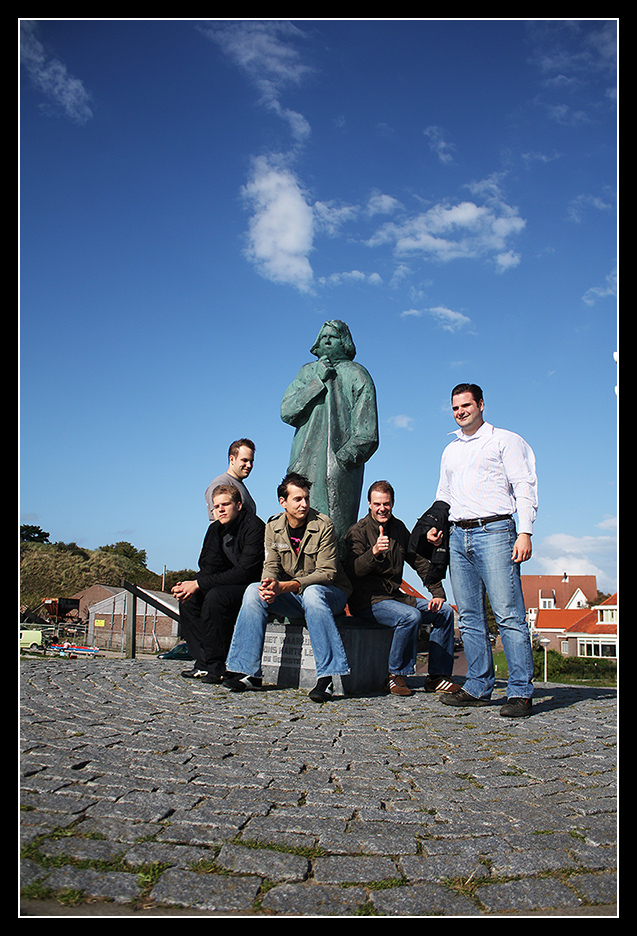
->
[449,520,533,699]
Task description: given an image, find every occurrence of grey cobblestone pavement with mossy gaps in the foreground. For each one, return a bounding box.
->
[20,657,617,917]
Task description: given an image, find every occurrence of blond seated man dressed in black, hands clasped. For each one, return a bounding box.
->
[172,484,265,683]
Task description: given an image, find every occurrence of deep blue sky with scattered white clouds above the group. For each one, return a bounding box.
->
[20,19,618,591]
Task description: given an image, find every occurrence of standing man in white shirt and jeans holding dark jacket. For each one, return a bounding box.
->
[427,384,537,717]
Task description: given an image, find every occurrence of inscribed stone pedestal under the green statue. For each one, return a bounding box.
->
[262,615,393,695]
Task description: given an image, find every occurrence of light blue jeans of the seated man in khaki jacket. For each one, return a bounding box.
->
[226,583,349,677]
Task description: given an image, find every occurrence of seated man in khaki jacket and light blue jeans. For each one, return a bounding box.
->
[223,473,351,702]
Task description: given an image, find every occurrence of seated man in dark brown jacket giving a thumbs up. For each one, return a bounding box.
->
[345,481,459,696]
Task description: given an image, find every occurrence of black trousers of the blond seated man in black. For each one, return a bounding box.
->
[179,585,245,676]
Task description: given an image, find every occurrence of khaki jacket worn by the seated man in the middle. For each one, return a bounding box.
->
[263,509,352,597]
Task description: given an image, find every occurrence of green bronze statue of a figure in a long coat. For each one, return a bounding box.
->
[281,319,378,545]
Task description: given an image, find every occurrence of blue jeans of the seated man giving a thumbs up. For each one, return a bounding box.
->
[359,598,454,676]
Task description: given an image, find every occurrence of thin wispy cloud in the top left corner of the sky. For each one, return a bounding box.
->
[20,20,93,124]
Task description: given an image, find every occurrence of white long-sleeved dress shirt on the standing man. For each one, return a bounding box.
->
[436,422,537,534]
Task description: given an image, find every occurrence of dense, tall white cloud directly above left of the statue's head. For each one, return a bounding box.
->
[243,156,314,292]
